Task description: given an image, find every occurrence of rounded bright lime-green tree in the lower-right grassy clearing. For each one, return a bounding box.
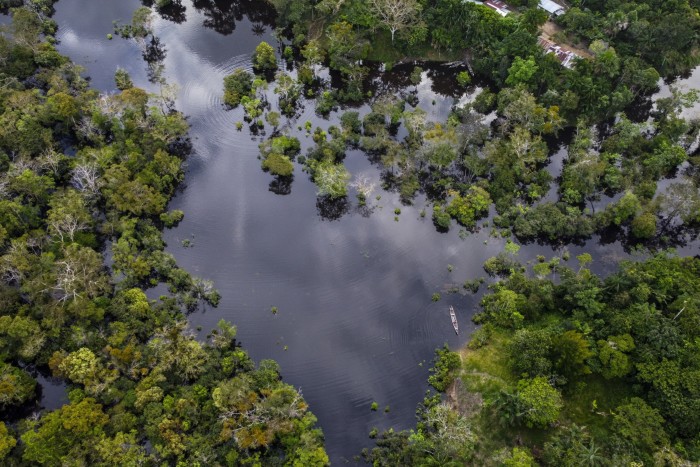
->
[517,376,563,427]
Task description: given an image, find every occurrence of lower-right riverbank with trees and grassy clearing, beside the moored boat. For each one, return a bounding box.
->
[445,253,700,465]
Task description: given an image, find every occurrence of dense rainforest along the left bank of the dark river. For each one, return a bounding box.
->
[0,1,328,466]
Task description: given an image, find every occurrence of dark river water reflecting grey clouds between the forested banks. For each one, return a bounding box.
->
[13,0,697,463]
